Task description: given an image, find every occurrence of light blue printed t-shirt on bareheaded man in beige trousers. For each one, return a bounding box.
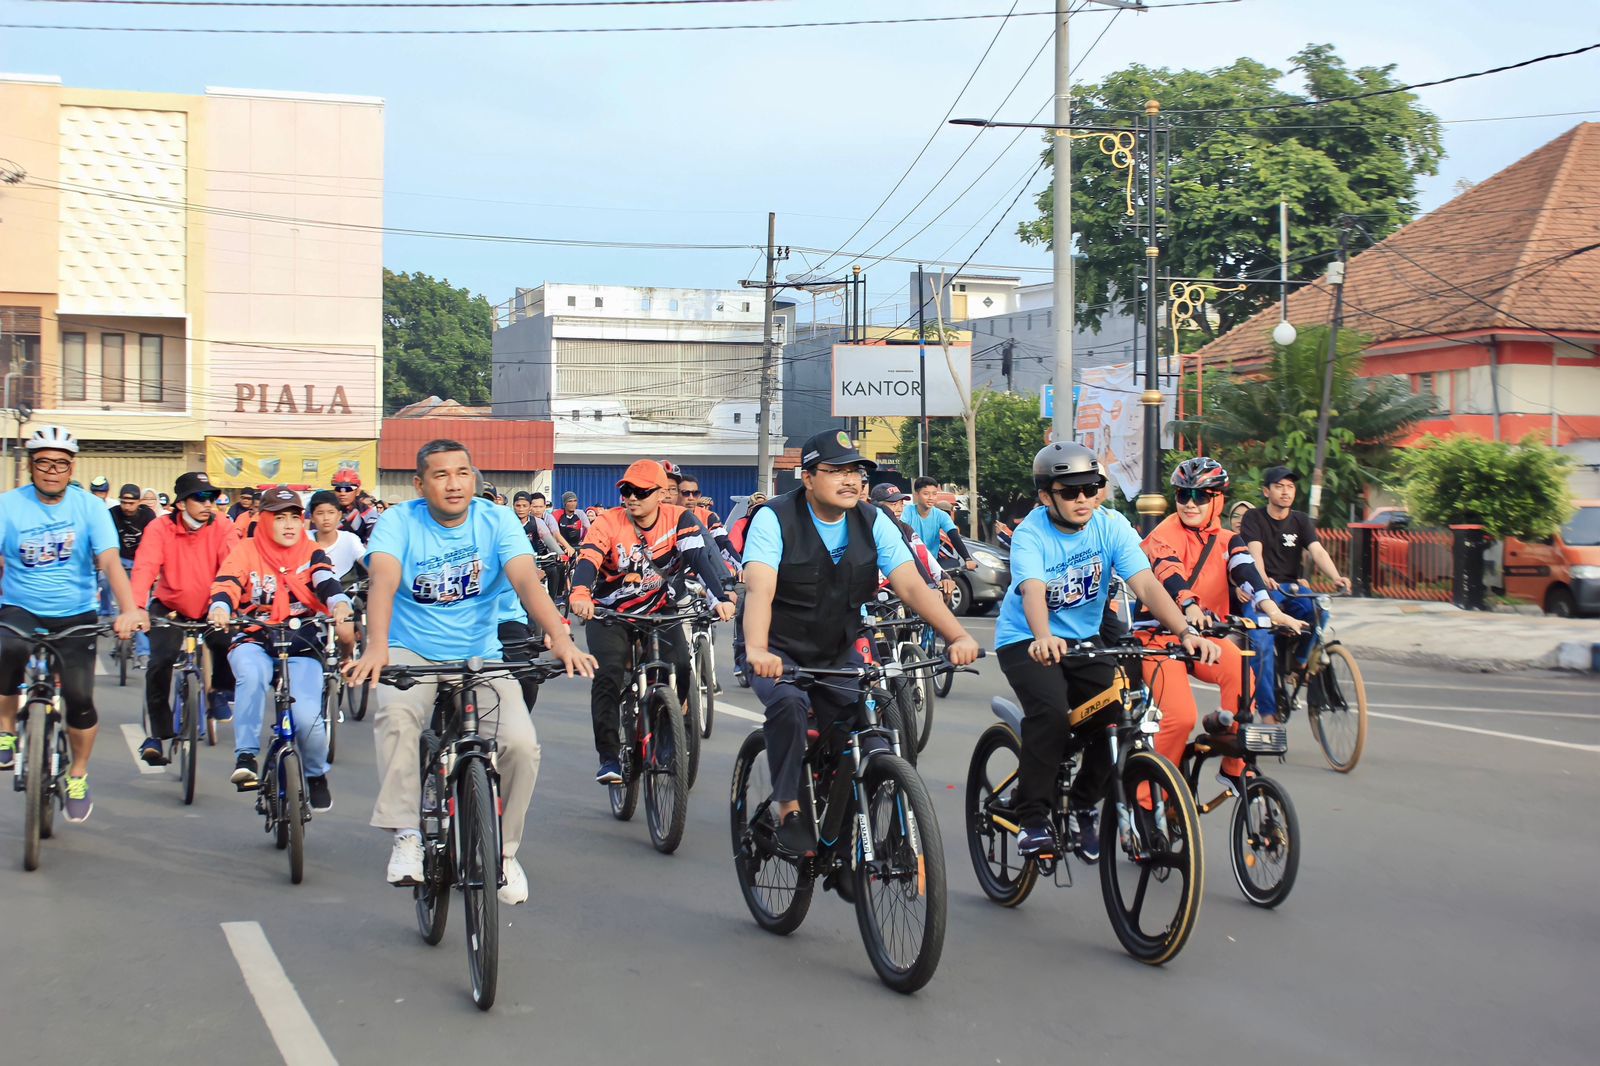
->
[366,499,533,661]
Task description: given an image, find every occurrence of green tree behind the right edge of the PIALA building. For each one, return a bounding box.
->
[384,269,494,411]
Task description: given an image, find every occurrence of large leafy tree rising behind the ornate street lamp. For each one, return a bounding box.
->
[1018,45,1443,331]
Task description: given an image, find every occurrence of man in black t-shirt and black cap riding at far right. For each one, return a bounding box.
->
[1238,466,1350,722]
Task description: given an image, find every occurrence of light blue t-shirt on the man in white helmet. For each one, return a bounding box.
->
[0,485,122,618]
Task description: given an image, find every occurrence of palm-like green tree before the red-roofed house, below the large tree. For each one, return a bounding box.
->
[1174,327,1434,525]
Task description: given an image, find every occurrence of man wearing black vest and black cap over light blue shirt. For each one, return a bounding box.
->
[742,432,978,856]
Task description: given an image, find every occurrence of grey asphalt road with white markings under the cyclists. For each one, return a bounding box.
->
[0,619,1600,1066]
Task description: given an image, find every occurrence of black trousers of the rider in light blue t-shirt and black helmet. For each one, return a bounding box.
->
[995,640,1117,824]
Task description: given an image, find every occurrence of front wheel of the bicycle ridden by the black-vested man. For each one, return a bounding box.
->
[856,755,946,992]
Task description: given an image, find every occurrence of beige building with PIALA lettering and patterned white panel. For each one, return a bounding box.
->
[0,74,384,491]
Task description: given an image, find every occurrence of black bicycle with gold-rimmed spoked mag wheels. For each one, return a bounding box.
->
[966,640,1205,965]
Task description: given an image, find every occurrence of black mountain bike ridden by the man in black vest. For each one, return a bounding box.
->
[730,659,962,994]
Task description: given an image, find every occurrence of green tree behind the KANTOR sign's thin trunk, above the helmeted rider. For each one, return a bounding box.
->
[894,389,1046,514]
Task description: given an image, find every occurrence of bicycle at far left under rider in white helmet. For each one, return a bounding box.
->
[0,623,112,871]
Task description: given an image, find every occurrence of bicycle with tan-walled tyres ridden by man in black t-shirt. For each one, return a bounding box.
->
[1274,592,1366,773]
